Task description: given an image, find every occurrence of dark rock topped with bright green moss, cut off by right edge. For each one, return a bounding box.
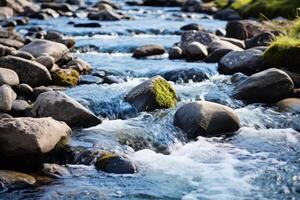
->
[264,36,300,72]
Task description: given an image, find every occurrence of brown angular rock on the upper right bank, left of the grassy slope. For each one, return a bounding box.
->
[226,20,265,40]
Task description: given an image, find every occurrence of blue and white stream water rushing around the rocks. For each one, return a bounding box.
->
[0,1,300,200]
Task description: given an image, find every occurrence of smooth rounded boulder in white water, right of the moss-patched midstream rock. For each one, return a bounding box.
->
[174,101,240,139]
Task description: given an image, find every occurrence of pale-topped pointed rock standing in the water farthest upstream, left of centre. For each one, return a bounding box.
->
[87,9,125,21]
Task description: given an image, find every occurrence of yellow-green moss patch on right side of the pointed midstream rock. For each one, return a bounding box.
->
[153,78,177,108]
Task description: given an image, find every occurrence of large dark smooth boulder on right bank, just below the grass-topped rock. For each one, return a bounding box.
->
[233,68,294,103]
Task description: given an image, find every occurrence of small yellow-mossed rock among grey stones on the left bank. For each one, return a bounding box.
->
[51,69,80,86]
